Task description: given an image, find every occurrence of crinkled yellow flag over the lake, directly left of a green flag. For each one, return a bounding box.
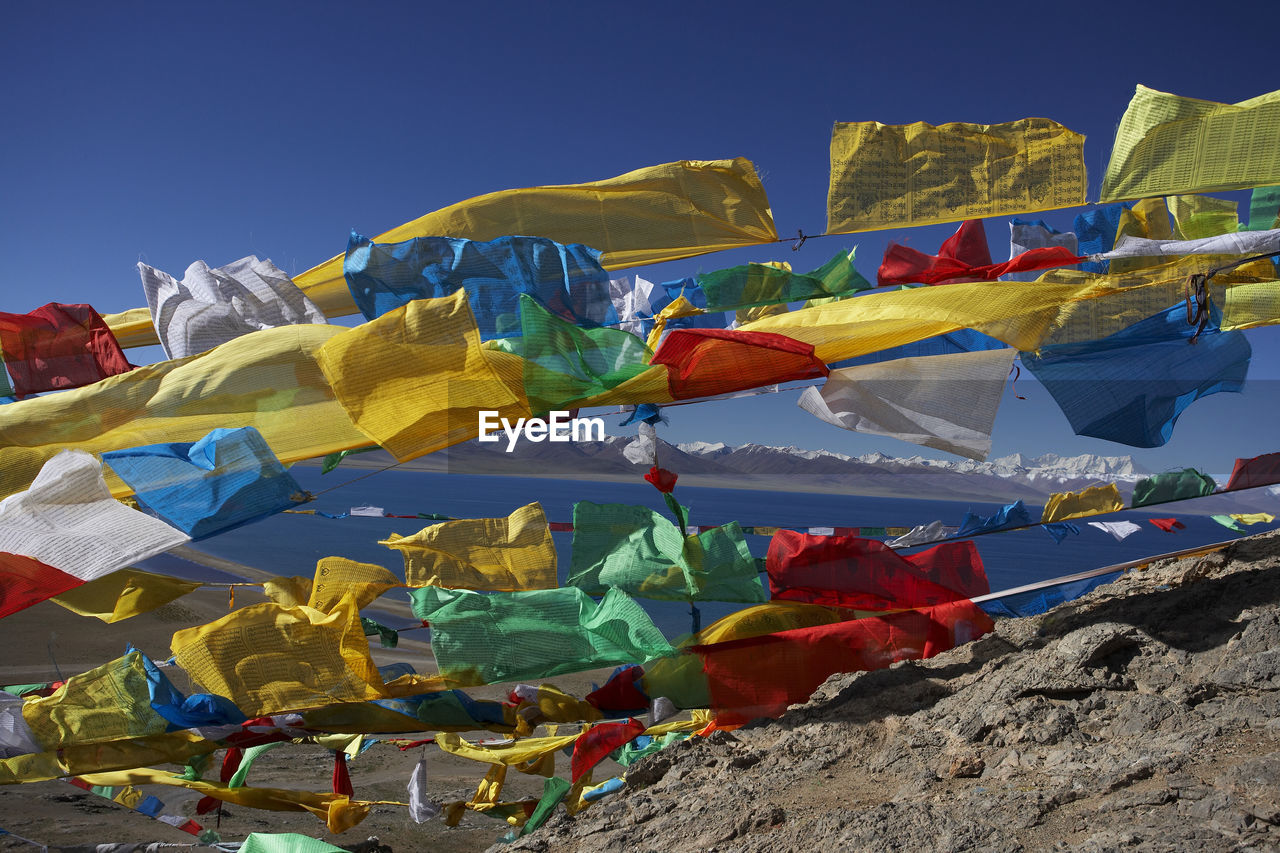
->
[379,502,557,592]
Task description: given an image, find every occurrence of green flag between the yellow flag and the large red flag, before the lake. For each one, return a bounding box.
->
[564,501,765,603]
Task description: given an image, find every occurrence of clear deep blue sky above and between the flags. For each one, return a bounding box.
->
[0,1,1280,471]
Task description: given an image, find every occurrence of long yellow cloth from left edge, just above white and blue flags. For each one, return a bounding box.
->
[0,325,369,496]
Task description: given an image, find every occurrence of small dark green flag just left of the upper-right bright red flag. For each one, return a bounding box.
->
[698,251,870,311]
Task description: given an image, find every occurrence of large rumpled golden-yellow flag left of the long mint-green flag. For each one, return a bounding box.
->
[173,596,385,717]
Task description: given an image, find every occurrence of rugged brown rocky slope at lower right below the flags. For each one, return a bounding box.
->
[504,533,1280,852]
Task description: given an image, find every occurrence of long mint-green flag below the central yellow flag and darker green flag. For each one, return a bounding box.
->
[410,587,673,684]
